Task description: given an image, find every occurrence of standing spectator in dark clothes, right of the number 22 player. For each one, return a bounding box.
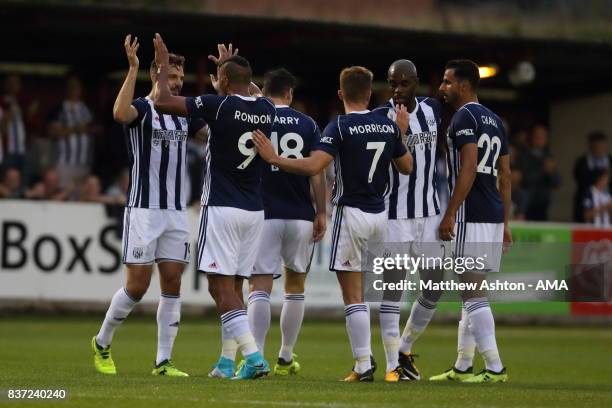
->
[518,125,560,221]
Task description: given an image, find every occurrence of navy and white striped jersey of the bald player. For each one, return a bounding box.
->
[374,97,442,220]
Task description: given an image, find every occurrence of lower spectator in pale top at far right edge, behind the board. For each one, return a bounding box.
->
[582,169,612,228]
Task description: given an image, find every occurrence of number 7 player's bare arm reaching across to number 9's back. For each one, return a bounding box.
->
[253,130,334,176]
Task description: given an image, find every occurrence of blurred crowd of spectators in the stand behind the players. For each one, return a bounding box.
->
[0,74,612,226]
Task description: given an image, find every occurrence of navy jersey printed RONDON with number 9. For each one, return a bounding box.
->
[186,95,276,211]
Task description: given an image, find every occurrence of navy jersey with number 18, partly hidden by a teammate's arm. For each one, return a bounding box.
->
[261,105,321,221]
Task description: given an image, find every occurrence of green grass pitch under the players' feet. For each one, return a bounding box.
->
[0,315,612,408]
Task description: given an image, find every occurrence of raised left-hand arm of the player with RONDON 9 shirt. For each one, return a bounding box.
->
[153,33,189,117]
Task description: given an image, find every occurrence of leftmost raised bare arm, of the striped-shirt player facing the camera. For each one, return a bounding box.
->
[113,34,140,125]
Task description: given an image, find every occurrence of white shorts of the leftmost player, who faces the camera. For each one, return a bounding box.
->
[122,207,191,265]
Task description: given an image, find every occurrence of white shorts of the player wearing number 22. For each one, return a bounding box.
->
[452,222,504,272]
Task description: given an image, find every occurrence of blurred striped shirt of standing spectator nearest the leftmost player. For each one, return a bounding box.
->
[52,100,93,166]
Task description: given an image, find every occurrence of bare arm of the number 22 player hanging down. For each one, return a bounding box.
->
[438,143,478,241]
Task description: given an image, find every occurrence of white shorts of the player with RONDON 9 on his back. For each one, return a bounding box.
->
[197,206,264,278]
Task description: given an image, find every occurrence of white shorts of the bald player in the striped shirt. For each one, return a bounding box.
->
[387,214,444,257]
